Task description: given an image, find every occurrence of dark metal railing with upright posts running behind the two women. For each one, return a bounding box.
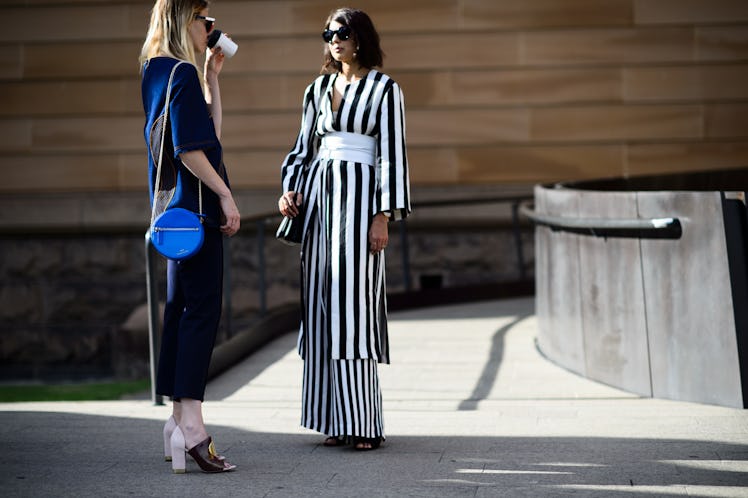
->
[145,195,531,405]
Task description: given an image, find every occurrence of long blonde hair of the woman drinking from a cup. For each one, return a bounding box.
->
[139,0,208,68]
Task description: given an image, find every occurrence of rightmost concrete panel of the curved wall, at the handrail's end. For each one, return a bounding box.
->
[639,192,743,407]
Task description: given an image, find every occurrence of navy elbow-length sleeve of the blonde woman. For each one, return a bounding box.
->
[169,64,219,157]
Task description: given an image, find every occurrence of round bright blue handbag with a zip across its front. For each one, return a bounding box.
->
[151,208,205,261]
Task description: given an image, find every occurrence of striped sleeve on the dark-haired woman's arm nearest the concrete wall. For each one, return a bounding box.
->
[373,82,410,220]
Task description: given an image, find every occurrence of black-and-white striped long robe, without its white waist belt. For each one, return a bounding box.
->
[281,70,410,363]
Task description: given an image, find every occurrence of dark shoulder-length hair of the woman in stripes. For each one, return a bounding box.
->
[320,7,384,74]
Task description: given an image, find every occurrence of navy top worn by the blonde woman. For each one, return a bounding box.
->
[141,57,229,227]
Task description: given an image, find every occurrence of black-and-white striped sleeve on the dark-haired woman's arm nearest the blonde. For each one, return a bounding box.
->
[281,80,319,192]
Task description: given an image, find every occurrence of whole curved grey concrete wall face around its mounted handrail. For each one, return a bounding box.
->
[535,186,744,408]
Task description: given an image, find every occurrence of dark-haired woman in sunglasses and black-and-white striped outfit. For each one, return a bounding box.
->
[278,9,410,450]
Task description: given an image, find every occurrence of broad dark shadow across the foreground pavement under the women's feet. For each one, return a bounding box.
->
[0,412,748,497]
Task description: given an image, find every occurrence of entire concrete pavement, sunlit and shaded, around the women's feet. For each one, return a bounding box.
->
[0,298,748,497]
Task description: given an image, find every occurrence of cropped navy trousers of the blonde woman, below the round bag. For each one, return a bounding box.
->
[156,227,223,401]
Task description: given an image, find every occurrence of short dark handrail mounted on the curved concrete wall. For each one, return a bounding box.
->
[519,203,683,239]
